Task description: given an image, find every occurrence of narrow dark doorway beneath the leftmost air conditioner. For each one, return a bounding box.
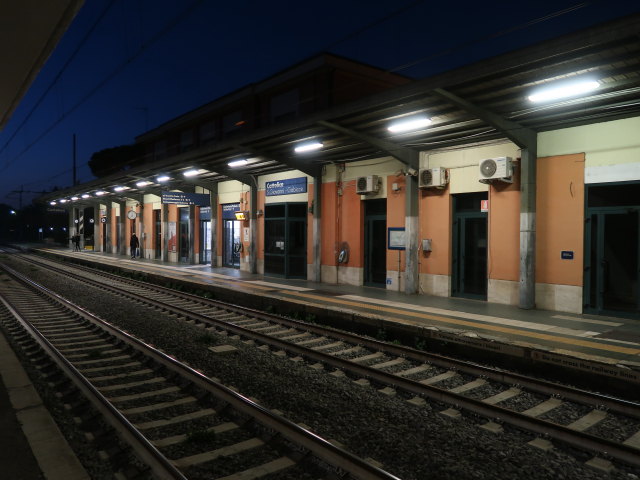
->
[363,199,387,288]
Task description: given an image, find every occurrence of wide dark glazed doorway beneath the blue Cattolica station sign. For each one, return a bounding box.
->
[264,203,307,278]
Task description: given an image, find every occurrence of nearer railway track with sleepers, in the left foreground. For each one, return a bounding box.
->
[0,256,397,480]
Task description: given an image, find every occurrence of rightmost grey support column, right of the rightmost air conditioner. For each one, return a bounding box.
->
[519,140,538,309]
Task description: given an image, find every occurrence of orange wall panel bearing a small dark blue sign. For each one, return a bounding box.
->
[536,153,585,286]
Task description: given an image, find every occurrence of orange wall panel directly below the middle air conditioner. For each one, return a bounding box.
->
[419,187,451,275]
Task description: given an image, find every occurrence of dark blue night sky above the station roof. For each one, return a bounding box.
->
[0,0,640,207]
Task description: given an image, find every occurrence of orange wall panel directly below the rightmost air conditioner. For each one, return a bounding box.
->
[487,172,520,282]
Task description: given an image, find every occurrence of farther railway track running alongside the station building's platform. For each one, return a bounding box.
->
[6,251,640,468]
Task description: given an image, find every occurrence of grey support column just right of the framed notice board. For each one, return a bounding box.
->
[404,175,419,294]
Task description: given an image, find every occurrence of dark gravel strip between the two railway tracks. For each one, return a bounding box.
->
[5,261,640,480]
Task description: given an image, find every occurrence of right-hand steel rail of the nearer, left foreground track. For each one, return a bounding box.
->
[0,264,400,480]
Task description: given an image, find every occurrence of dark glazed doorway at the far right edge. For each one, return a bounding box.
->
[584,183,640,318]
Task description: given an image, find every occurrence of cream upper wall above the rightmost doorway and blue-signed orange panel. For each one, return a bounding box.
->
[538,117,640,183]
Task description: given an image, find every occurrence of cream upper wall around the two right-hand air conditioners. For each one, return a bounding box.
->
[420,142,520,194]
